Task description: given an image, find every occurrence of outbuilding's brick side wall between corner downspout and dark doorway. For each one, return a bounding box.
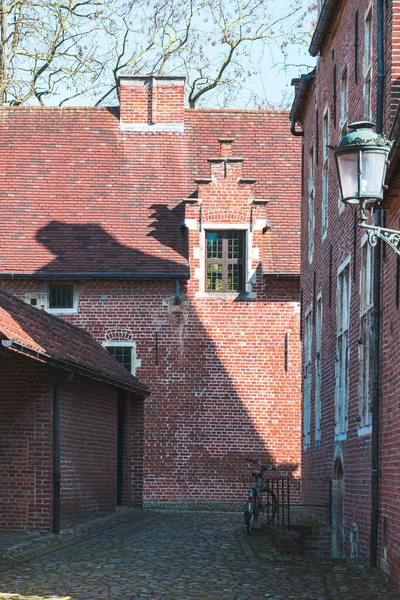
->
[60,377,118,519]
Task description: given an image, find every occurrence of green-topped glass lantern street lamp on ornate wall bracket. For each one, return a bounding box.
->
[330,121,400,256]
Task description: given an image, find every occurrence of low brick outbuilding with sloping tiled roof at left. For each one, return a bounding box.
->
[0,292,148,533]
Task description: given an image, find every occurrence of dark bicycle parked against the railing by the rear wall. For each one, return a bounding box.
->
[244,458,278,533]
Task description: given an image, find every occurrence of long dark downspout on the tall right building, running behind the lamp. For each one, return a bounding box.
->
[370,0,385,568]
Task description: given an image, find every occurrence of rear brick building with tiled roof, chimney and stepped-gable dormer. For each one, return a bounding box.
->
[0,76,300,524]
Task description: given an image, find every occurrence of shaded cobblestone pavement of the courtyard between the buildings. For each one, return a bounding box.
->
[0,511,400,600]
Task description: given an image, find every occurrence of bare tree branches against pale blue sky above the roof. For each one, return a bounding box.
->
[0,0,318,107]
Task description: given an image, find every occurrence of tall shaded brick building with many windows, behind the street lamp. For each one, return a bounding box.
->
[290,0,400,584]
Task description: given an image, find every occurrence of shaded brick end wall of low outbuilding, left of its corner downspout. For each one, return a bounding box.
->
[0,350,55,531]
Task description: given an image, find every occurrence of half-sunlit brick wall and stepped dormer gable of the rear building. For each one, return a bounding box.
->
[1,139,300,505]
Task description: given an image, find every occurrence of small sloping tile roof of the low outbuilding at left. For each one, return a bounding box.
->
[0,291,149,396]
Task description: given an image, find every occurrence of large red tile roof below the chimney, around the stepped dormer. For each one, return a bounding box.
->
[0,107,301,277]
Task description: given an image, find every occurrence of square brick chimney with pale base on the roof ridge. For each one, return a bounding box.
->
[119,75,185,132]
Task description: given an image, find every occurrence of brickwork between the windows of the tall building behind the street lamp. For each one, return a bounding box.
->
[301,0,400,582]
